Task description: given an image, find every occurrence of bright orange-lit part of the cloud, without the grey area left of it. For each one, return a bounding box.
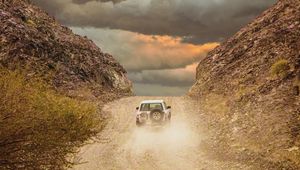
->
[123,34,218,71]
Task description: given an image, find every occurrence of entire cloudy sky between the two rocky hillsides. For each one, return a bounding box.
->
[32,0,276,96]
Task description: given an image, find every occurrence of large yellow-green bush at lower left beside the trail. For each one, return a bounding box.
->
[0,69,101,169]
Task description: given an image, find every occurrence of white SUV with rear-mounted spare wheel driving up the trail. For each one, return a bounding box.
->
[136,100,171,126]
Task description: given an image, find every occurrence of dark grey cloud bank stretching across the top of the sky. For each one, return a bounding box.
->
[33,0,276,43]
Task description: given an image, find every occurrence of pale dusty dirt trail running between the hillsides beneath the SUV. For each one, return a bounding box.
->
[74,97,250,170]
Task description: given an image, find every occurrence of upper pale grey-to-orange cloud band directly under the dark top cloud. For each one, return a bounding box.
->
[72,28,218,72]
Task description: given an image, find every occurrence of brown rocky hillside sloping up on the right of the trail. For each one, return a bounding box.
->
[189,0,300,168]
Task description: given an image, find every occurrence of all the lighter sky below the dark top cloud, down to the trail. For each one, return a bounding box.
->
[73,28,219,95]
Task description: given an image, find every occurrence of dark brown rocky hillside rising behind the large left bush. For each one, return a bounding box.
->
[0,0,131,99]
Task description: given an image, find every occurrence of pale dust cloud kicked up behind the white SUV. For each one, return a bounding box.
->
[129,120,199,154]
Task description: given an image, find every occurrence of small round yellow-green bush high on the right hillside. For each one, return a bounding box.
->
[271,59,291,78]
